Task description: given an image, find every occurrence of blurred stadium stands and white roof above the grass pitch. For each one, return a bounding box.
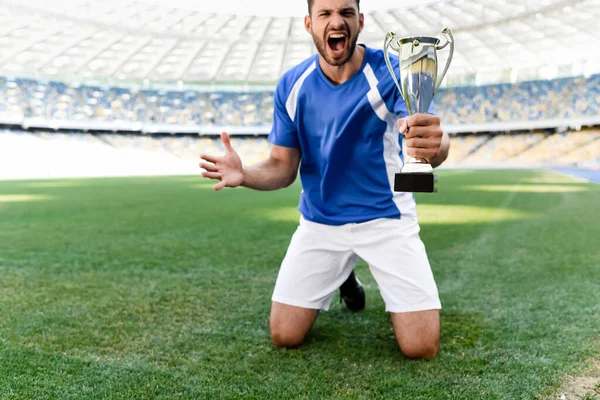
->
[0,0,600,179]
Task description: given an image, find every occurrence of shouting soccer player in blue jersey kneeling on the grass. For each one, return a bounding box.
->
[200,0,450,358]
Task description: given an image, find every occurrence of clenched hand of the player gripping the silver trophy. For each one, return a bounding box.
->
[398,114,450,168]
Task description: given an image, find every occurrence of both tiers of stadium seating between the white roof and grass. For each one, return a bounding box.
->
[0,75,600,179]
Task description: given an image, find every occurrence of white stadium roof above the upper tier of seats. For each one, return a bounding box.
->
[0,0,600,83]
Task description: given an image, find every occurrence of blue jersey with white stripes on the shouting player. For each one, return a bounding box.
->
[269,47,432,225]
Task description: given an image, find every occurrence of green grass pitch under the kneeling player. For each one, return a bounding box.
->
[0,171,600,399]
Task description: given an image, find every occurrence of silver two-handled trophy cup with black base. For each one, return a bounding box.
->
[383,28,454,193]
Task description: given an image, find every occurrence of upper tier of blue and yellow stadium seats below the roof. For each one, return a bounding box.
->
[0,75,600,127]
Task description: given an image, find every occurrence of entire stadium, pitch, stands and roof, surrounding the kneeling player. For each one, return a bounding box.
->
[0,0,600,400]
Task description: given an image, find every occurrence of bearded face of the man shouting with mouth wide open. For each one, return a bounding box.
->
[304,0,364,67]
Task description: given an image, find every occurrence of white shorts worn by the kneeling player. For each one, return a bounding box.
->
[272,218,441,313]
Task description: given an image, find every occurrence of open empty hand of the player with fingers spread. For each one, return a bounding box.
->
[200,132,244,191]
